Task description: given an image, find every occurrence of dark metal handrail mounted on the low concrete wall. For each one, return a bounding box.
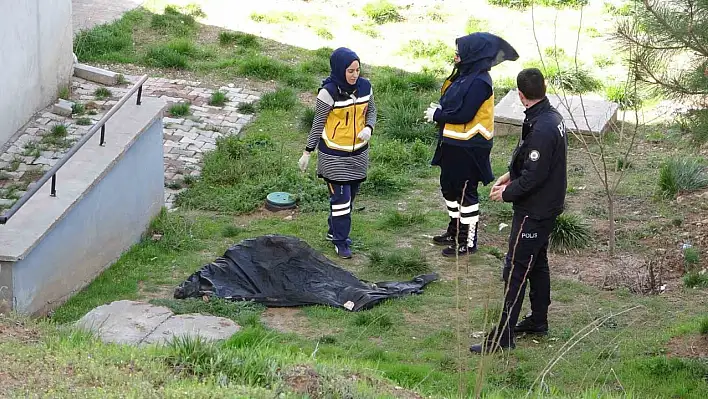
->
[0,75,148,224]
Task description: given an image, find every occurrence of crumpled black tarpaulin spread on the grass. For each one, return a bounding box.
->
[174,235,438,311]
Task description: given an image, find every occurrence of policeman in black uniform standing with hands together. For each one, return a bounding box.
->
[470,68,568,353]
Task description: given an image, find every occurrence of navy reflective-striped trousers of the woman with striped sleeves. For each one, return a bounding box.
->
[327,183,359,245]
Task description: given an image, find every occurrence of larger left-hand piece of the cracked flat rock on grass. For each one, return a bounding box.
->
[76,301,173,344]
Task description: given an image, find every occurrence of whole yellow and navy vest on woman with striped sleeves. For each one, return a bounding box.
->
[320,78,371,155]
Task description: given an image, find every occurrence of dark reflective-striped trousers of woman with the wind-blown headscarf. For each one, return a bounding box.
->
[440,172,479,248]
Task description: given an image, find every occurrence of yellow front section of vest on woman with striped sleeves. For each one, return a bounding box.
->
[322,94,371,152]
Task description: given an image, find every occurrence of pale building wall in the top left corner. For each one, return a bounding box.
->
[0,0,74,146]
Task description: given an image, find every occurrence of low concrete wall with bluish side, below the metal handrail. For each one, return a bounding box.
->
[0,98,165,314]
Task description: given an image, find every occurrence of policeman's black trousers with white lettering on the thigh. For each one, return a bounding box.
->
[494,212,556,345]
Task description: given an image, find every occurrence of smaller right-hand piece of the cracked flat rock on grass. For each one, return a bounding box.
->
[143,314,241,344]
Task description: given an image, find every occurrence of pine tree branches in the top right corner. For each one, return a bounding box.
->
[616,0,708,142]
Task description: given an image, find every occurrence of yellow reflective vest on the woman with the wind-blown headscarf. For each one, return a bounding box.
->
[440,75,494,147]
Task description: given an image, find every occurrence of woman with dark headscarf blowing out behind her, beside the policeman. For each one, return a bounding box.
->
[425,32,519,257]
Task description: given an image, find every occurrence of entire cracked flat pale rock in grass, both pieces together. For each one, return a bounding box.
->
[76,300,241,345]
